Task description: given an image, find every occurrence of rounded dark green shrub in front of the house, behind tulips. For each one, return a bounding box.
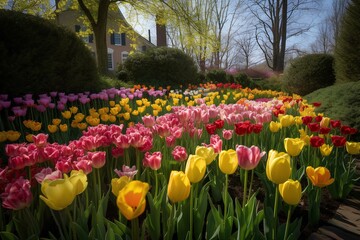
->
[124,47,197,87]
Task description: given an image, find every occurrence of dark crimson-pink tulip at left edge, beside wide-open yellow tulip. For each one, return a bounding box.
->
[0,177,33,210]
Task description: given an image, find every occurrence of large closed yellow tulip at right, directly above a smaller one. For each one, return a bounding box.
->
[266,150,291,184]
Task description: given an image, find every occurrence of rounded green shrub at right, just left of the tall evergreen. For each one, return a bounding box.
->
[284,54,335,96]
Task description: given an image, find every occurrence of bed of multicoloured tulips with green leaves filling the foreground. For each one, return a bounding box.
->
[0,84,360,239]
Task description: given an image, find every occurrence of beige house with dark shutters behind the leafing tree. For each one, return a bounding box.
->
[57,10,156,72]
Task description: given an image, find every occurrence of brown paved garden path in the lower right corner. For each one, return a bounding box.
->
[308,159,360,240]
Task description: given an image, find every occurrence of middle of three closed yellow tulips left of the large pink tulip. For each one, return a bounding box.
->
[185,154,206,183]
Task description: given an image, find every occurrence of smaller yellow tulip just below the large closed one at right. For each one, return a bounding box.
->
[279,179,301,205]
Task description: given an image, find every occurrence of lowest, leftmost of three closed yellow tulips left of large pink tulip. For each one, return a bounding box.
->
[167,171,190,203]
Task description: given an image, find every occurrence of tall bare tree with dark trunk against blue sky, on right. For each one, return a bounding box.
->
[248,0,316,72]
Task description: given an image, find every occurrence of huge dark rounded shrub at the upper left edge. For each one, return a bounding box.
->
[0,10,99,96]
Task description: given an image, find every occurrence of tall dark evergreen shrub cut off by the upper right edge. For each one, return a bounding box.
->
[334,1,360,83]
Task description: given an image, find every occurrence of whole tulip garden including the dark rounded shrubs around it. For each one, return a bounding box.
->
[0,2,360,240]
